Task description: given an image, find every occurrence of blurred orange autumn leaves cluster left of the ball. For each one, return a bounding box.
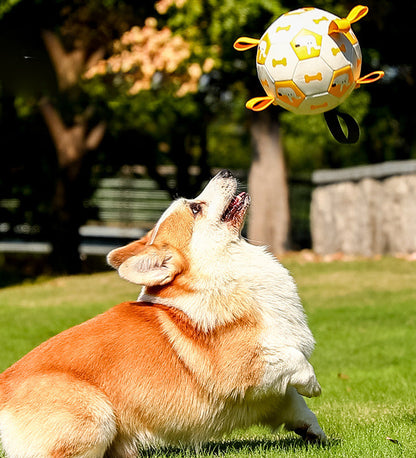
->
[85,8,214,97]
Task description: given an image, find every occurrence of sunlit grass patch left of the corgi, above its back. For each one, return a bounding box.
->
[0,272,139,371]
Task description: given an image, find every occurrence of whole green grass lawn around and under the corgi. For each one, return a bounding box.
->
[0,258,416,458]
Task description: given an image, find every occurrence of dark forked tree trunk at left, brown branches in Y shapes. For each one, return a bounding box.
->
[35,30,106,273]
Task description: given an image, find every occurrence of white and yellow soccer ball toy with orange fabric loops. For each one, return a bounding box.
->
[234,5,384,140]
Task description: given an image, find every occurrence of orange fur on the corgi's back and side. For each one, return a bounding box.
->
[0,303,264,456]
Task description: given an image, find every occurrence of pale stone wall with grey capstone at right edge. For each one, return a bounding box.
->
[311,161,416,256]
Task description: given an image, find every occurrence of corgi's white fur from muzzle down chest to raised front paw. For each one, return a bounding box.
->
[138,174,321,397]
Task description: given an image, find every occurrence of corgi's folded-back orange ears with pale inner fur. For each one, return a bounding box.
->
[107,239,184,286]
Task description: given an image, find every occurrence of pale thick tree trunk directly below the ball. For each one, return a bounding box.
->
[248,111,290,255]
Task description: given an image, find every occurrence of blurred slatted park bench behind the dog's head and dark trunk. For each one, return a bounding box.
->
[0,177,171,255]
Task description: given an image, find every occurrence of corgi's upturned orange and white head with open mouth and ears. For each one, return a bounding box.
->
[107,170,250,286]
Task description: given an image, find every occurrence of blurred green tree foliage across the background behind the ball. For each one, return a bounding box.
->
[2,0,416,180]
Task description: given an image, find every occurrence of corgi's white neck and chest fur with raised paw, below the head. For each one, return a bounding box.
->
[139,240,320,396]
